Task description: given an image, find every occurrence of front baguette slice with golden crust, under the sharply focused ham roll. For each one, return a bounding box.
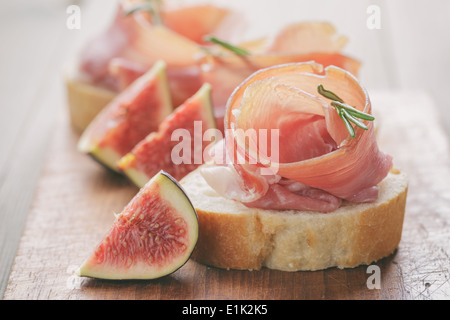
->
[181,167,408,271]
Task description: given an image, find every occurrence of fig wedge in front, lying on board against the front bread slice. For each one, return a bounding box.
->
[77,171,198,279]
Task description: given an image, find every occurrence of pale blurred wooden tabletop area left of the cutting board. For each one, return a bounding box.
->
[0,0,118,297]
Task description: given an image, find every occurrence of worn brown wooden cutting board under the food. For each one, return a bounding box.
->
[4,92,450,300]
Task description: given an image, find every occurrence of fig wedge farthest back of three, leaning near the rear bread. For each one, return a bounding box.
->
[78,60,173,172]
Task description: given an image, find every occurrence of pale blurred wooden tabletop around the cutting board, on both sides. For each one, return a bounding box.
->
[0,0,450,297]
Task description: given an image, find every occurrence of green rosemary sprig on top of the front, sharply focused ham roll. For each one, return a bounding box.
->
[317,84,375,138]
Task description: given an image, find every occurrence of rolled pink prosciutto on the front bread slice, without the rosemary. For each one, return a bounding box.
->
[203,62,392,212]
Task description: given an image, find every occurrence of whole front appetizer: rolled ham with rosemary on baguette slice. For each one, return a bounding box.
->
[181,62,408,271]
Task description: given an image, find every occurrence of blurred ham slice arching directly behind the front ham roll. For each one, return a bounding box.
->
[200,22,360,132]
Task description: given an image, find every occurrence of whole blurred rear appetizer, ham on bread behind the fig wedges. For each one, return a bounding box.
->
[65,0,359,131]
